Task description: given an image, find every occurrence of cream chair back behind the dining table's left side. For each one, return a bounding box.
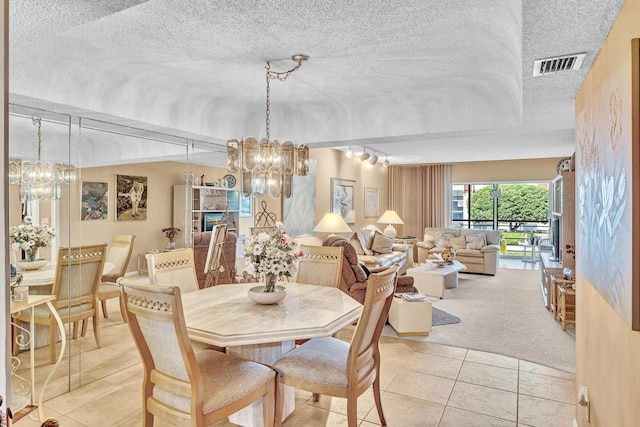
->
[146,248,199,293]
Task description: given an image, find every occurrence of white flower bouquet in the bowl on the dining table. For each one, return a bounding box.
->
[242,222,302,292]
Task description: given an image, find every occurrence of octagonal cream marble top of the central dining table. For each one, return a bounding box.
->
[182,282,362,347]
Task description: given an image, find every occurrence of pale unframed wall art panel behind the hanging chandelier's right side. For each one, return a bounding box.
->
[282,159,318,237]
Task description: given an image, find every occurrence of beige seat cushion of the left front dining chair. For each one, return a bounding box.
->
[153,350,275,414]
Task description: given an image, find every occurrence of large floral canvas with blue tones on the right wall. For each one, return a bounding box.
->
[576,37,640,330]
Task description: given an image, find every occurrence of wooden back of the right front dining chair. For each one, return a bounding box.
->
[347,264,399,390]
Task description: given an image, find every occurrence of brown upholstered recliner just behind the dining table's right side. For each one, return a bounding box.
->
[322,236,416,304]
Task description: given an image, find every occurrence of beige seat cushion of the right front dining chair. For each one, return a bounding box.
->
[273,337,349,387]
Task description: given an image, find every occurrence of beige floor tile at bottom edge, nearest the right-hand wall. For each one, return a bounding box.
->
[518,395,576,427]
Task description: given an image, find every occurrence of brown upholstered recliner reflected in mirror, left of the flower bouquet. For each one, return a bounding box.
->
[193,231,238,289]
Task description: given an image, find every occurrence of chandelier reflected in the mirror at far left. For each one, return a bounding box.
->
[9,118,76,201]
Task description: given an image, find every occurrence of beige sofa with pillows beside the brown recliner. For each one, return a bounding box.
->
[350,226,413,276]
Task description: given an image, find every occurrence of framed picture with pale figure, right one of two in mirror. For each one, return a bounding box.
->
[116,175,147,221]
